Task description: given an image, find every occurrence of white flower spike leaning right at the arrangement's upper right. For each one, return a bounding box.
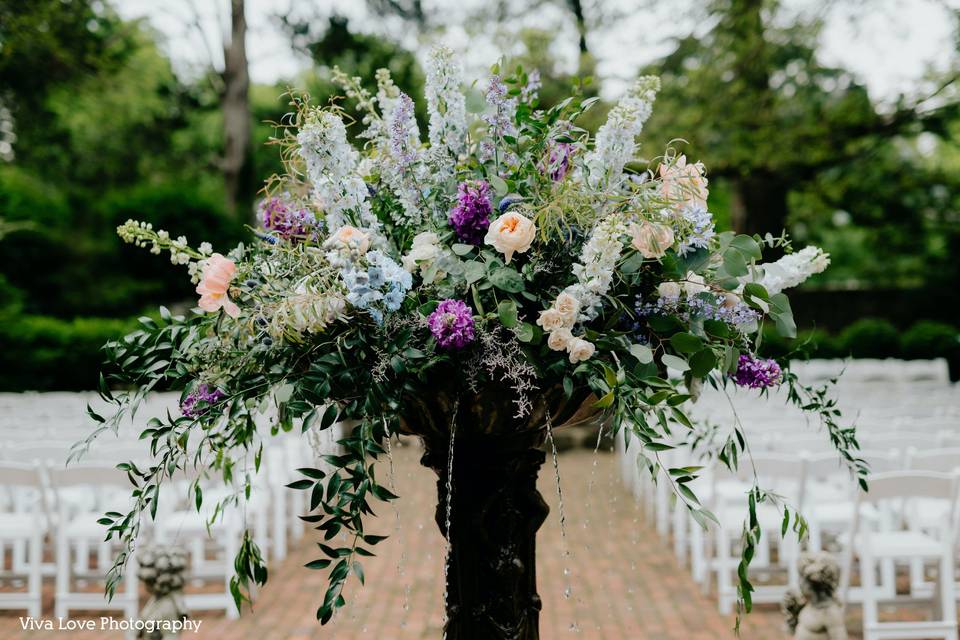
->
[584,76,660,188]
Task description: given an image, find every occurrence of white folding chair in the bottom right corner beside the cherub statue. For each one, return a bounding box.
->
[843,471,957,640]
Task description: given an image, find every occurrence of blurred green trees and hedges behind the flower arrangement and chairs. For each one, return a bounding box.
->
[0,0,960,389]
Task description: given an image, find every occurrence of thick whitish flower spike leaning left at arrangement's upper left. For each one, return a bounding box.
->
[297,110,380,235]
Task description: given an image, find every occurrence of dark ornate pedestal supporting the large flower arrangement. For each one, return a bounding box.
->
[420,430,550,640]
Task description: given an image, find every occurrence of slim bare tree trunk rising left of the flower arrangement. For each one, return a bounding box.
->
[222,0,253,216]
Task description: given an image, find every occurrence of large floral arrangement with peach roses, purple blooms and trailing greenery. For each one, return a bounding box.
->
[87,48,863,622]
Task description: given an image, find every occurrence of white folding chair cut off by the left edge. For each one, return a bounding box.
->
[0,461,47,617]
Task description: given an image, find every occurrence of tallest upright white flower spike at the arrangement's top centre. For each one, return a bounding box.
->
[425,45,467,175]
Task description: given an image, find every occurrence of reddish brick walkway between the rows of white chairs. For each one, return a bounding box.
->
[0,440,786,640]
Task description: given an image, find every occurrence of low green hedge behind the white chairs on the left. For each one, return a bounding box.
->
[0,315,136,391]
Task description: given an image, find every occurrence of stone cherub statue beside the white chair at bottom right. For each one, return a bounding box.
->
[780,552,847,640]
